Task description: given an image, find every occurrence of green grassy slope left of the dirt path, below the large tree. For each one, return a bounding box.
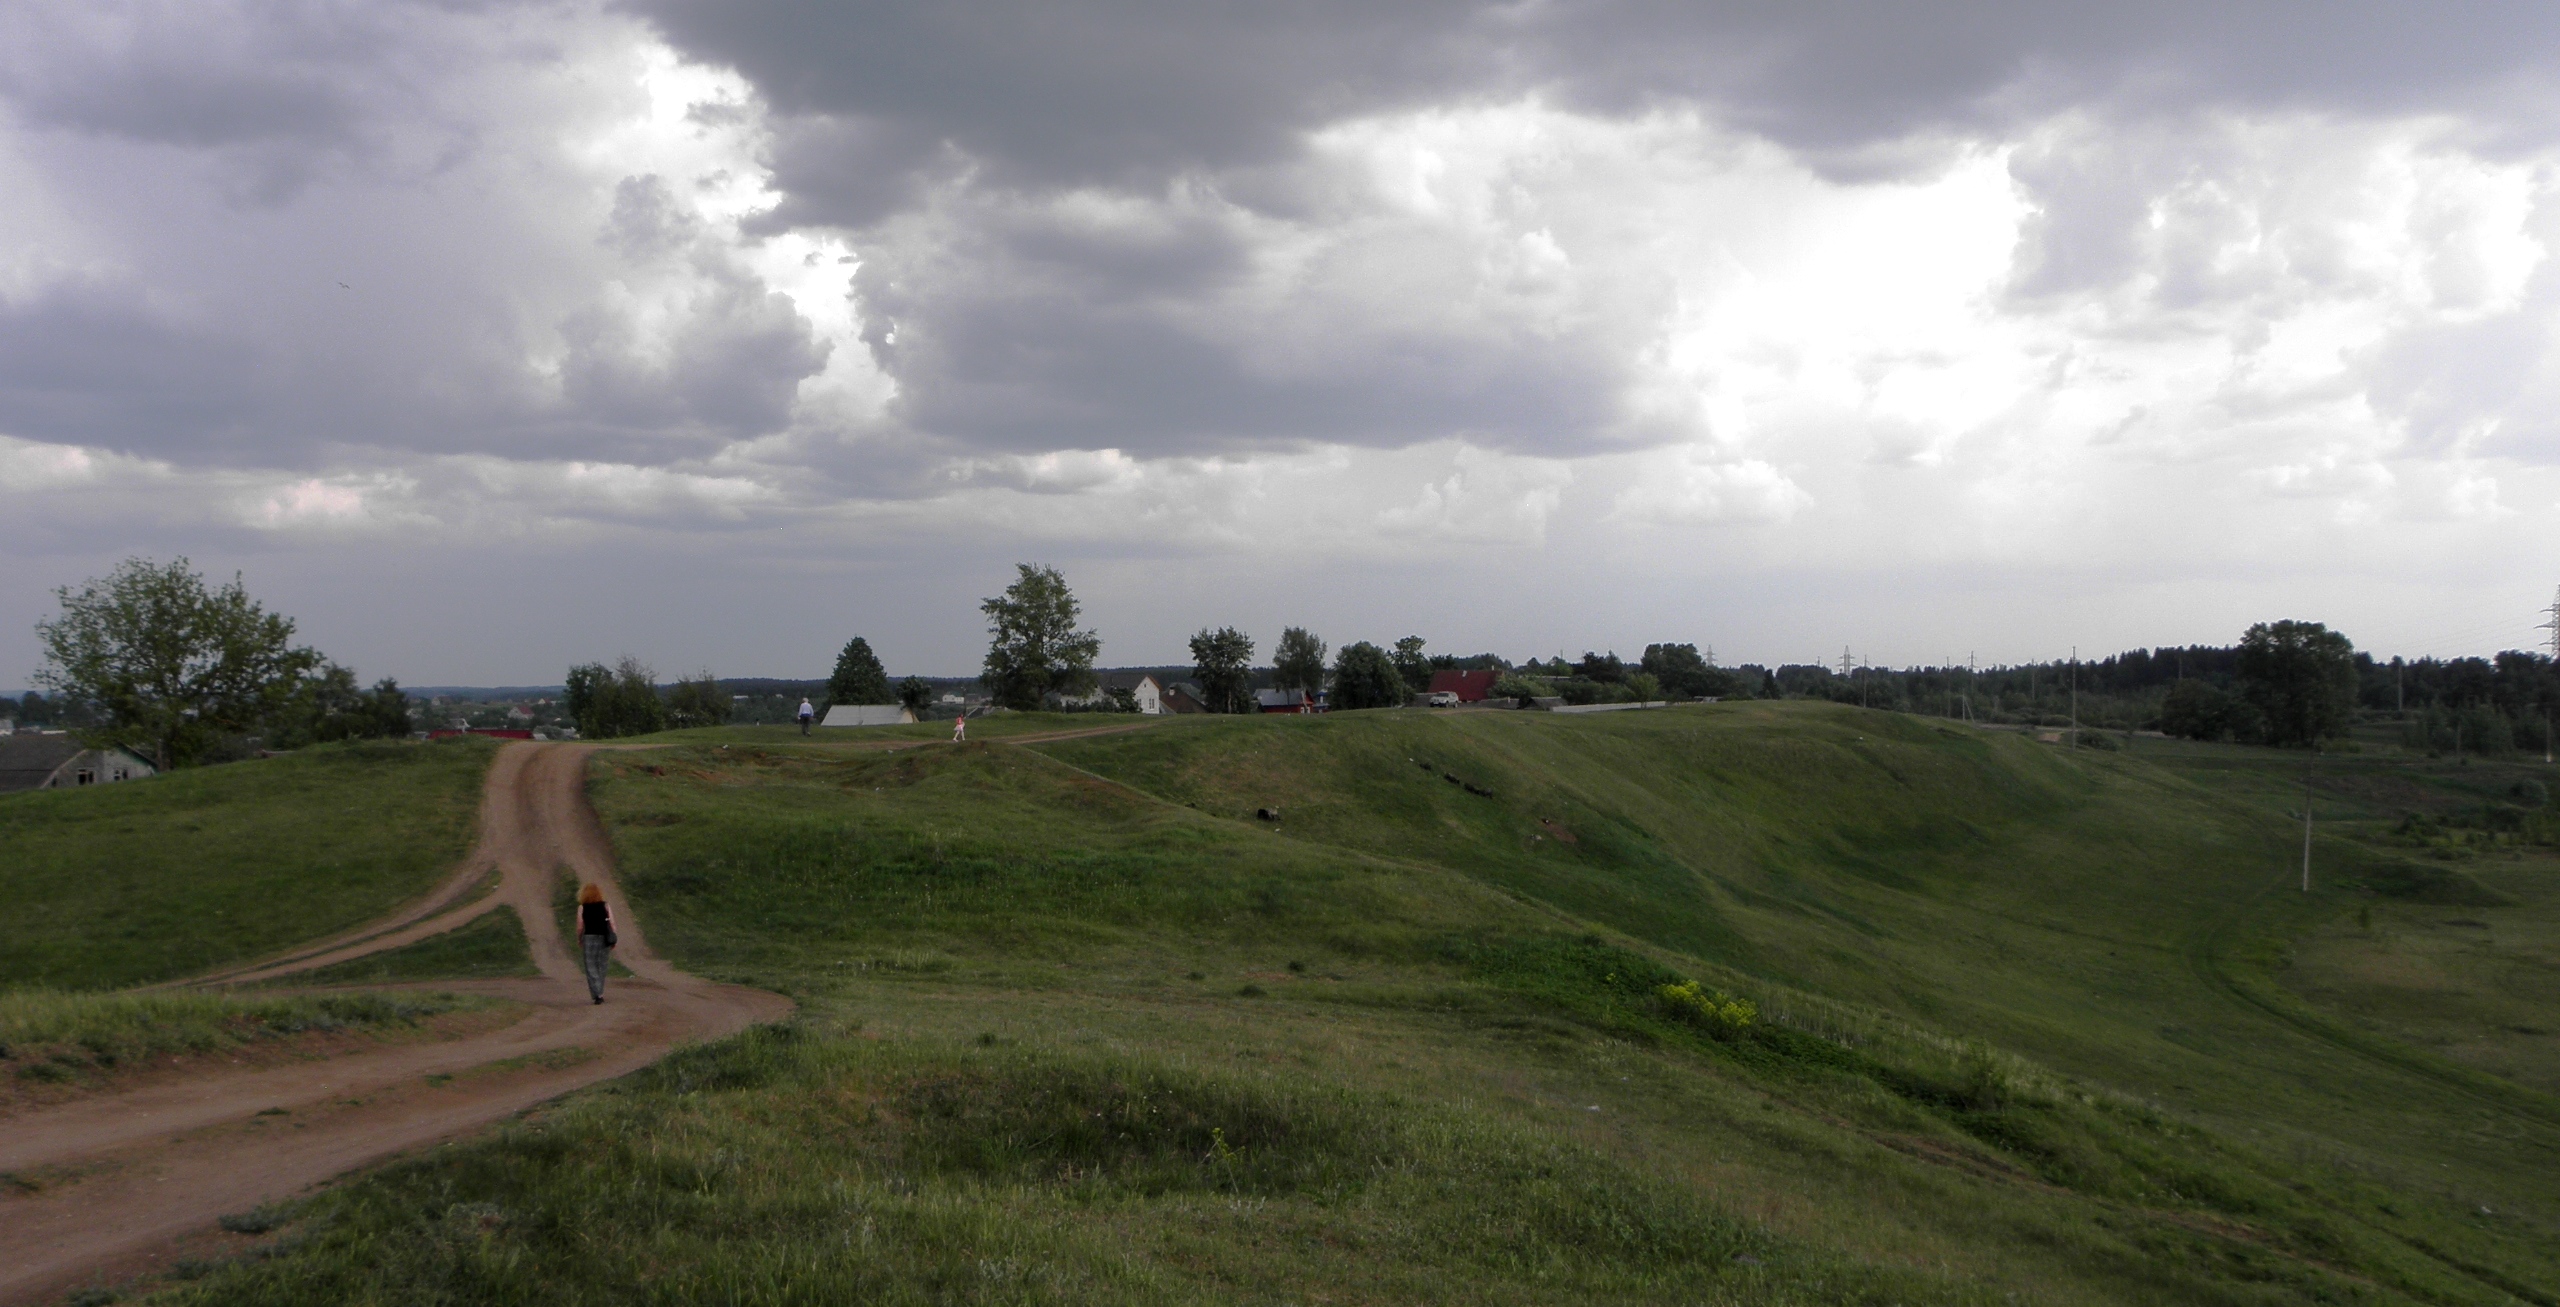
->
[0,739,494,990]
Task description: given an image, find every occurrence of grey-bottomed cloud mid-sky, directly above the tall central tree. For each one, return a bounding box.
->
[855,196,1626,455]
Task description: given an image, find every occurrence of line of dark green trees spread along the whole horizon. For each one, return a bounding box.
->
[30,558,2529,767]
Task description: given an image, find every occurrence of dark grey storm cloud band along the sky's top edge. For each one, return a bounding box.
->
[632,0,2560,194]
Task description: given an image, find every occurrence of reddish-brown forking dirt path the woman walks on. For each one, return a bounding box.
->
[0,744,791,1304]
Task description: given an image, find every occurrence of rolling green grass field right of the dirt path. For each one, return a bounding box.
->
[49,703,2560,1304]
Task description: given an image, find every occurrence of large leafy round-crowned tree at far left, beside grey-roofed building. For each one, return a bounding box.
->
[36,558,320,770]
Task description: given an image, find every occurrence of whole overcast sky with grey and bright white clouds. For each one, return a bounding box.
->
[0,0,2560,685]
